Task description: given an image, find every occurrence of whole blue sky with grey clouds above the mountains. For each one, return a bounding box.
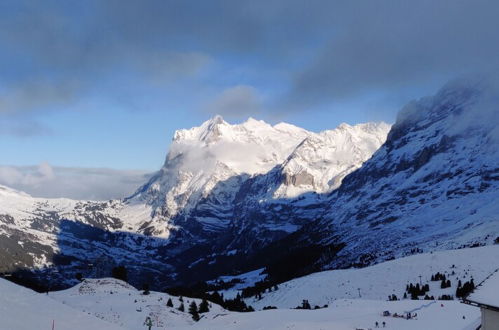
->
[0,0,499,198]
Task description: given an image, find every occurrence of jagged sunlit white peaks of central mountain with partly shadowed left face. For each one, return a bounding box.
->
[127,116,390,237]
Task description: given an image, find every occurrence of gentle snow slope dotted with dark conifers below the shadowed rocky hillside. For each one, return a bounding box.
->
[249,245,499,309]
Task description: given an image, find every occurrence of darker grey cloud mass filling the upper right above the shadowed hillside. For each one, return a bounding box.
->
[285,1,499,108]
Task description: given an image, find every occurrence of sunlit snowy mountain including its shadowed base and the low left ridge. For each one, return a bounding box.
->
[0,116,389,285]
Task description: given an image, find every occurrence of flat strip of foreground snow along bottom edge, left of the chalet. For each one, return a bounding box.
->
[183,299,480,330]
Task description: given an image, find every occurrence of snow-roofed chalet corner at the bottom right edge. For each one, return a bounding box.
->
[464,270,499,330]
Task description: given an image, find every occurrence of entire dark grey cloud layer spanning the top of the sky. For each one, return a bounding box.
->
[0,0,499,125]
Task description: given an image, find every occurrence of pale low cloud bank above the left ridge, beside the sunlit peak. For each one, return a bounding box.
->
[0,163,151,200]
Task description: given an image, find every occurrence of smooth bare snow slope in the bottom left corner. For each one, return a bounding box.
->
[0,278,122,330]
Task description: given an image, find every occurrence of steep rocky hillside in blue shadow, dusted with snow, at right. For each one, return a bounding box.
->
[292,78,499,268]
